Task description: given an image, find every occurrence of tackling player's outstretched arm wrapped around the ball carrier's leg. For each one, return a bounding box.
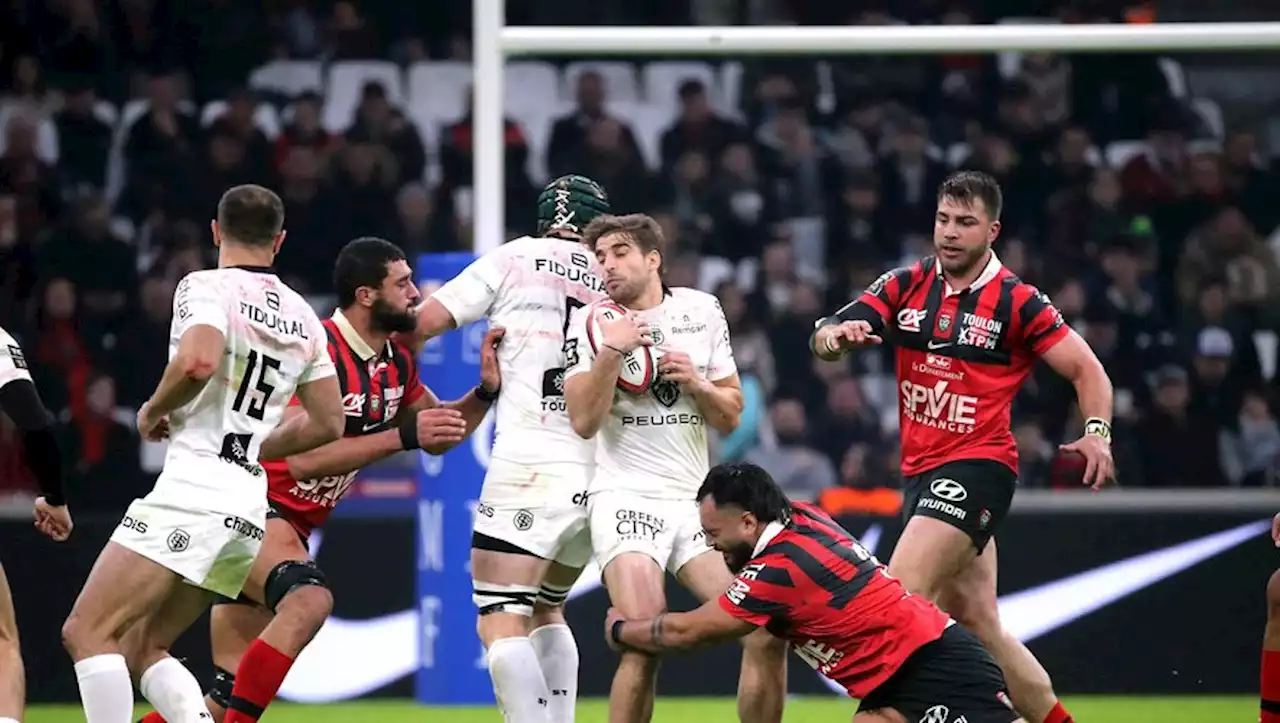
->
[604,600,756,653]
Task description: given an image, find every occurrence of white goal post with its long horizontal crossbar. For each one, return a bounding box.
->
[472,0,1280,255]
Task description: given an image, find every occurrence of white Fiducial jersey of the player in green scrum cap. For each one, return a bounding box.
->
[433,235,605,465]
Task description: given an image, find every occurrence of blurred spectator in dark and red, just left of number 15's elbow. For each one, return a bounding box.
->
[60,374,150,513]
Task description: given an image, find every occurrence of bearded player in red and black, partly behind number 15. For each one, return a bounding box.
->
[142,238,502,723]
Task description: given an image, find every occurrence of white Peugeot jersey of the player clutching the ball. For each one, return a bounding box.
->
[566,288,737,499]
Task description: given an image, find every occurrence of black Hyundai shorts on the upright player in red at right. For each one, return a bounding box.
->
[902,459,1018,554]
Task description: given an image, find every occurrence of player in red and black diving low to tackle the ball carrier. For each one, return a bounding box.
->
[605,462,1021,723]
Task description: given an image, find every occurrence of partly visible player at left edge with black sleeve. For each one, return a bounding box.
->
[0,329,72,723]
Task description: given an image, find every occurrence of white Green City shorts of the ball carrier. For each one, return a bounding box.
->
[588,490,713,575]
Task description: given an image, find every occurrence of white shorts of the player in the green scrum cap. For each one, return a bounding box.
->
[472,459,591,568]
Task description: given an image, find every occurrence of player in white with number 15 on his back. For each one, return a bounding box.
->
[63,186,343,723]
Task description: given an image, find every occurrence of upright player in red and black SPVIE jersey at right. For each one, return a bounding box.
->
[810,171,1115,723]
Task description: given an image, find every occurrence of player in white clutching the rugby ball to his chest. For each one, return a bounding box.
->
[564,214,786,723]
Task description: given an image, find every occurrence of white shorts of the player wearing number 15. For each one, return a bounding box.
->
[111,497,266,599]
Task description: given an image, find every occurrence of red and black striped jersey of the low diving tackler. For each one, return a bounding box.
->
[719,503,951,697]
